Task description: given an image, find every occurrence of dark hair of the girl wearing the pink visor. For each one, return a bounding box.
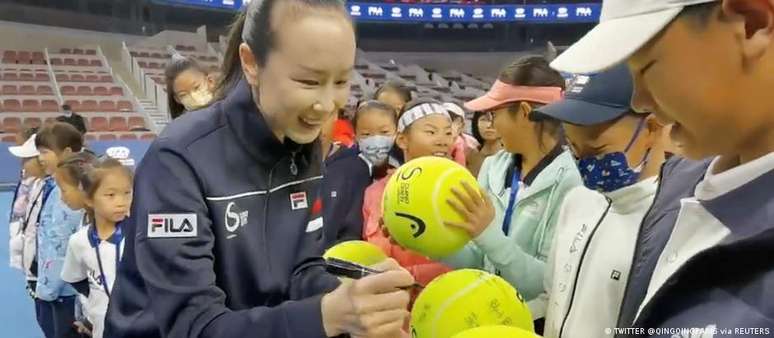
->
[498,56,566,150]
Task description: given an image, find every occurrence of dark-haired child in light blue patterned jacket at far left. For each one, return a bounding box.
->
[35,122,83,338]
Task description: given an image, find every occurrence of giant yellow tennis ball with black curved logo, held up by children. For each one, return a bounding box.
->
[383,156,478,258]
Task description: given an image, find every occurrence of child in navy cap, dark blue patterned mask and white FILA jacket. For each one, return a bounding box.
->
[538,65,665,338]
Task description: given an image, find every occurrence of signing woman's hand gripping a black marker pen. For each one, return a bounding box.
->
[321,258,414,338]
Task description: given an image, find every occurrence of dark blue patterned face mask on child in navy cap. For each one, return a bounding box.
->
[578,119,650,192]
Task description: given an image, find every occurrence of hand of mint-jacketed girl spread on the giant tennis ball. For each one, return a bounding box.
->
[444,182,495,238]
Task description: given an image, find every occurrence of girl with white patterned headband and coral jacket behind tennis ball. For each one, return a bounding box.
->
[363,100,454,285]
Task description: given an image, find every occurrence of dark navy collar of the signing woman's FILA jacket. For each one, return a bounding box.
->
[222,79,320,167]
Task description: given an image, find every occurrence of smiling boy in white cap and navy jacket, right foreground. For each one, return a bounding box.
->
[554,0,774,337]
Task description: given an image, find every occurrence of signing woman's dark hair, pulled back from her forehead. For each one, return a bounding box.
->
[215,0,349,99]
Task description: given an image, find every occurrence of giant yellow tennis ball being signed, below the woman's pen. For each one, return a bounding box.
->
[411,269,534,338]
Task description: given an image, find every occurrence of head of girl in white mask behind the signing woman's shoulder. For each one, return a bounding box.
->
[164,54,215,119]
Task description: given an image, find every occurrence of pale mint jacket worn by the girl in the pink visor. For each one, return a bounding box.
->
[443,150,582,312]
